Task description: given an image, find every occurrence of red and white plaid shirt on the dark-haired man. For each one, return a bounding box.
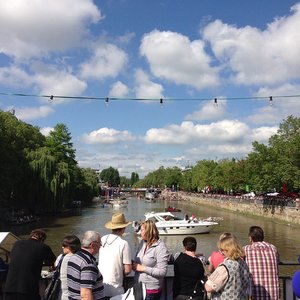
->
[244,242,279,300]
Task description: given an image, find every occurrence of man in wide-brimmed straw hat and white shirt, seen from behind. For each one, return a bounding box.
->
[98,213,132,298]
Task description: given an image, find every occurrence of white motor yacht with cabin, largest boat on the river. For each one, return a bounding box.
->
[139,212,219,235]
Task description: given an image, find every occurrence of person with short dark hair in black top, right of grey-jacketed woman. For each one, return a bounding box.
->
[173,236,206,300]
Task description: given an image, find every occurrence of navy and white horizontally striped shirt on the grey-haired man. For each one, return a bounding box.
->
[67,249,104,300]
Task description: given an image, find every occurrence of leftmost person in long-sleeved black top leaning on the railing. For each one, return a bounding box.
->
[4,229,56,300]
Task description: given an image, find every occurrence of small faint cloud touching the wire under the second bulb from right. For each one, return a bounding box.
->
[185,100,227,121]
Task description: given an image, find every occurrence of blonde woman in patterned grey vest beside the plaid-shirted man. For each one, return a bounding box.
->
[205,235,250,300]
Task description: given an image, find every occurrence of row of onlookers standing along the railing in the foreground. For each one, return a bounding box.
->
[4,213,298,300]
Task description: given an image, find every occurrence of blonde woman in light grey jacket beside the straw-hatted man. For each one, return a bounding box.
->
[133,220,170,300]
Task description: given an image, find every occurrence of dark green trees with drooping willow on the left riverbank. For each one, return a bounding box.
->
[0,111,101,217]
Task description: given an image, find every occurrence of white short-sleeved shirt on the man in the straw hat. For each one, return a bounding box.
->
[98,234,131,297]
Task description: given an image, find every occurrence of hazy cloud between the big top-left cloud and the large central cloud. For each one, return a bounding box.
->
[80,43,128,79]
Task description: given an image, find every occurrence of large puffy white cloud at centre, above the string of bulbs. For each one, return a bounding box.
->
[140,30,219,90]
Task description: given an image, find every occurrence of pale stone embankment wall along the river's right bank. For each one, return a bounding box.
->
[160,191,300,226]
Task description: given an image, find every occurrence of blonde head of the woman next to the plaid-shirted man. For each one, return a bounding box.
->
[218,234,245,260]
